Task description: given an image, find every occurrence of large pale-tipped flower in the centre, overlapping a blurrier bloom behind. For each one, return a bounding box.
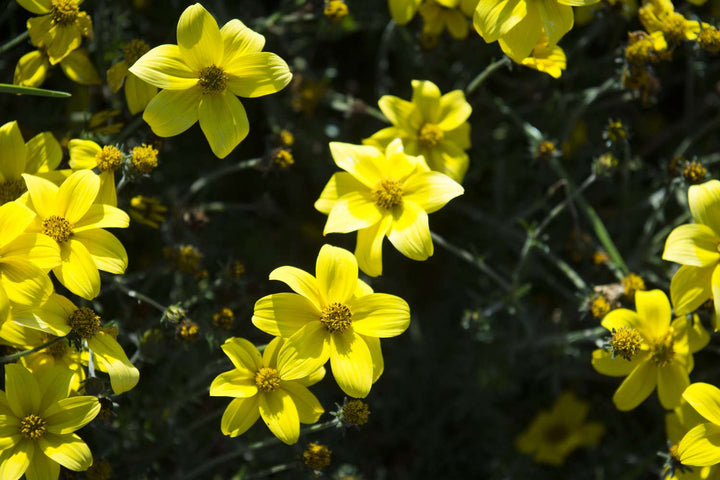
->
[315,139,464,277]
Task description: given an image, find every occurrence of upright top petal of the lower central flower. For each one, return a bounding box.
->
[315,245,358,304]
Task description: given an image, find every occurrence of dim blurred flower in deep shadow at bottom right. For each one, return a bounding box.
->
[515,392,605,466]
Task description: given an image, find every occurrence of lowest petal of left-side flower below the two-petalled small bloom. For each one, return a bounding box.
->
[53,238,100,300]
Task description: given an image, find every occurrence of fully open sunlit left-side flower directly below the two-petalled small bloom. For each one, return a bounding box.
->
[23,170,130,300]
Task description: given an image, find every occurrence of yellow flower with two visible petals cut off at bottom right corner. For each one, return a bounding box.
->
[677,383,720,467]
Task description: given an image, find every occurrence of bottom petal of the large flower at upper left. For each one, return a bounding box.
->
[198,90,250,158]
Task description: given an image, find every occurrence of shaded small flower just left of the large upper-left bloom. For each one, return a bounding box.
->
[107,40,158,115]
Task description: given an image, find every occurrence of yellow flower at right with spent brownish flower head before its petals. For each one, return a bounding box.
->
[592,290,709,411]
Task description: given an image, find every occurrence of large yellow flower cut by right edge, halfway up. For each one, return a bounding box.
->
[662,180,720,331]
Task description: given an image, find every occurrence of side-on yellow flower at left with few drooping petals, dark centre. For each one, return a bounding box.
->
[12,293,140,394]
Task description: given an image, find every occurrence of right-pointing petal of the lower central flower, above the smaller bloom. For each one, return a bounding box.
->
[349,293,410,338]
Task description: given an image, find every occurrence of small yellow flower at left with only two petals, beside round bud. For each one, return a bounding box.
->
[68,138,124,207]
